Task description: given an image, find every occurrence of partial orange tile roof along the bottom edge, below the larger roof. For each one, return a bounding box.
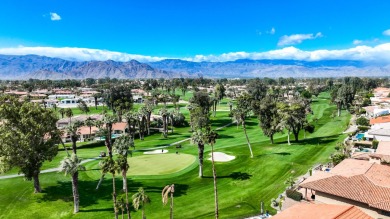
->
[272,203,373,219]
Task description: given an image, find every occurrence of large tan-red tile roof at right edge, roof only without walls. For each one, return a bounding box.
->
[300,159,390,211]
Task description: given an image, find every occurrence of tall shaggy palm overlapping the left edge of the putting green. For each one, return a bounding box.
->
[113,135,134,218]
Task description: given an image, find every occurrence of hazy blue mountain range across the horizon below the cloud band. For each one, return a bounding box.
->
[0,55,390,80]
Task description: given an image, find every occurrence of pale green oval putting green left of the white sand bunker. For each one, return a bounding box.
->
[128,154,196,176]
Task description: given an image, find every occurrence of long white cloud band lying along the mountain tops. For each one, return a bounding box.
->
[0,43,390,63]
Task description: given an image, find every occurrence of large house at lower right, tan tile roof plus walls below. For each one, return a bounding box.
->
[300,159,390,218]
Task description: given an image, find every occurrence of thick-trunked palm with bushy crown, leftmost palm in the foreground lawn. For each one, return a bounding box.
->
[60,154,85,213]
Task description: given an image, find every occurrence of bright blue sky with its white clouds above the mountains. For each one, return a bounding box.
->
[0,0,390,61]
